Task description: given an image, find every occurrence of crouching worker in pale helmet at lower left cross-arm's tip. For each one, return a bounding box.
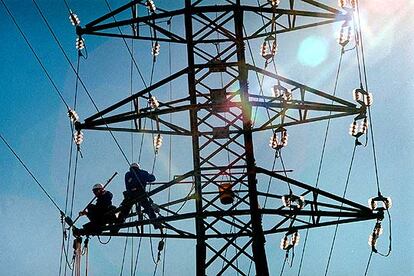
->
[78,183,116,234]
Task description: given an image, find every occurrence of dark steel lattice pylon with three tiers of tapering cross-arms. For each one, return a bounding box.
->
[73,0,383,275]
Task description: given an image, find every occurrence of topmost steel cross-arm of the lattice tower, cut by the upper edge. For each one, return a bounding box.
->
[77,0,351,44]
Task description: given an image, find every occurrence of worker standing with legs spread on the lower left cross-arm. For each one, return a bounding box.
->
[118,163,160,228]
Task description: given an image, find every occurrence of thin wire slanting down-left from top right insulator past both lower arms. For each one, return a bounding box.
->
[298,47,345,276]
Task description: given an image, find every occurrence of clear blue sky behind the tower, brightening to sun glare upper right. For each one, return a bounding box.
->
[0,0,414,275]
